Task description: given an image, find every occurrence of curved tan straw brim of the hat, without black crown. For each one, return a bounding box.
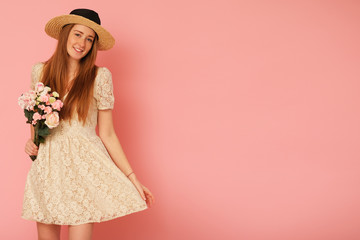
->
[45,14,115,50]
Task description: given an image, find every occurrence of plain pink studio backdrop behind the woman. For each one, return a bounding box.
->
[0,0,360,240]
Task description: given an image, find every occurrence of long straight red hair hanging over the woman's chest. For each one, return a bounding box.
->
[40,24,98,124]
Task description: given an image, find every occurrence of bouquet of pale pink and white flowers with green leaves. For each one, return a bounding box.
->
[18,82,63,161]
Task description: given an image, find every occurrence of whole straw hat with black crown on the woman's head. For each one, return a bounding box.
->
[45,8,115,50]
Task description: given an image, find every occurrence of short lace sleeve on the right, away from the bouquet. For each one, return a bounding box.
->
[95,67,115,110]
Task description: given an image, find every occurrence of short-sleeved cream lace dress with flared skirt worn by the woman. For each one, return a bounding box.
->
[21,63,147,225]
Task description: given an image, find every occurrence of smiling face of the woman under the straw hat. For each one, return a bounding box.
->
[67,24,95,61]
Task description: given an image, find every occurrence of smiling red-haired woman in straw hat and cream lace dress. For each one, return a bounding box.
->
[21,9,154,239]
